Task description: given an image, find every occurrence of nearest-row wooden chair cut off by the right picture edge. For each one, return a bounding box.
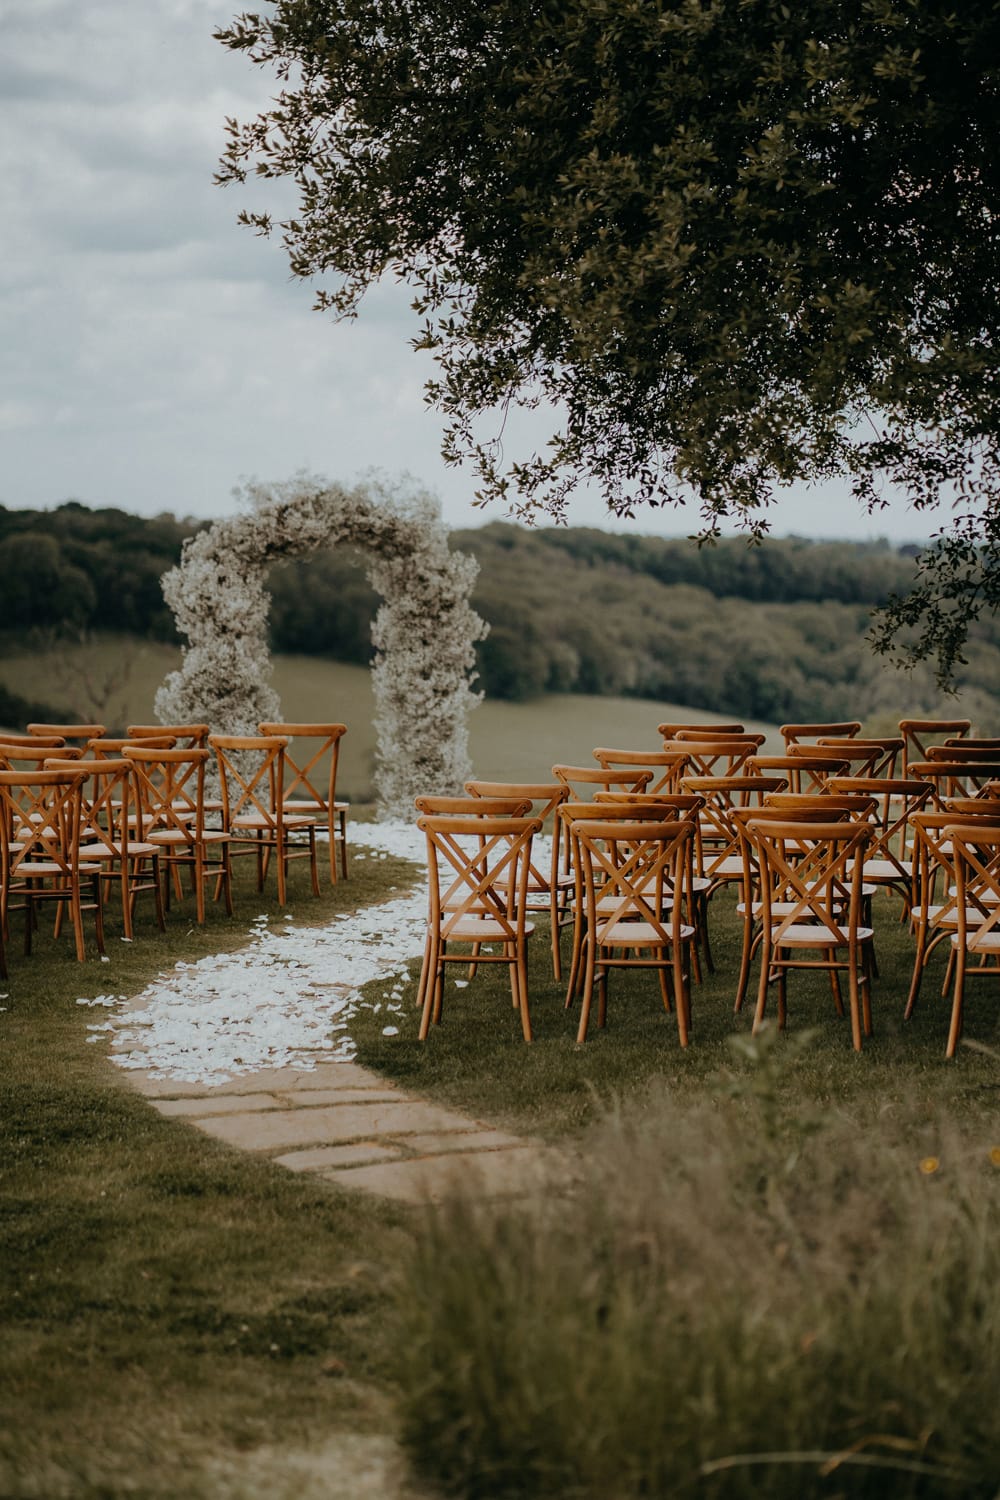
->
[945,822,1000,1058]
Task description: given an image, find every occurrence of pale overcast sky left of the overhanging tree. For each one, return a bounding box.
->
[0,0,931,542]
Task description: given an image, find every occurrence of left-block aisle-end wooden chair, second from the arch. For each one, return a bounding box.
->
[208,735,319,906]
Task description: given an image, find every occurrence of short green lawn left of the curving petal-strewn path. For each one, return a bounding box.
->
[0,860,425,1500]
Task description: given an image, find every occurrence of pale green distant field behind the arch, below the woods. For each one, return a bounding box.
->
[0,639,775,801]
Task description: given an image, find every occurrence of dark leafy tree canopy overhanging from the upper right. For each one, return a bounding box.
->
[219,0,1000,671]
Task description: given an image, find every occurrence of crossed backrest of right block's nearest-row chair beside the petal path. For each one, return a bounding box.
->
[417,813,541,942]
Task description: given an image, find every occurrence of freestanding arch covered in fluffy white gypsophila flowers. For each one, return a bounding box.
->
[156,479,489,818]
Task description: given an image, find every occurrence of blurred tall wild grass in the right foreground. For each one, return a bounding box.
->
[397,1043,1000,1500]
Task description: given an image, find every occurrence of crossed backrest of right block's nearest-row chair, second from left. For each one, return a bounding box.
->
[570,819,694,947]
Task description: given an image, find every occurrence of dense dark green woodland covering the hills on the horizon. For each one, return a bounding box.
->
[0,501,1000,728]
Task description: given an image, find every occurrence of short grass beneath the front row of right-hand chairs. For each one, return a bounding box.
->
[351,894,1000,1149]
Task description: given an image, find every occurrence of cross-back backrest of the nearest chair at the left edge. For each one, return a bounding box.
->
[0,767,84,884]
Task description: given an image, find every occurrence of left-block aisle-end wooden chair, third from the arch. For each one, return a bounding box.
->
[121,743,232,926]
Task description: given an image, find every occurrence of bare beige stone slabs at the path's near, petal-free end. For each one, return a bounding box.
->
[130,1062,559,1203]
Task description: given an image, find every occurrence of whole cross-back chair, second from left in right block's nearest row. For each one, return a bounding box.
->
[570,819,694,1047]
